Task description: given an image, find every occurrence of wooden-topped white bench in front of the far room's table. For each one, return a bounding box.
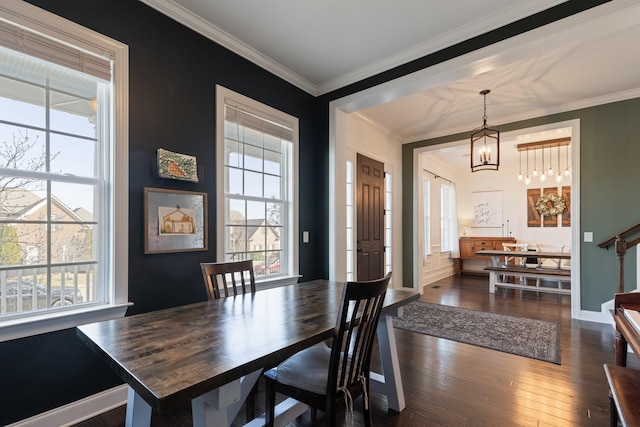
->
[484,265,571,295]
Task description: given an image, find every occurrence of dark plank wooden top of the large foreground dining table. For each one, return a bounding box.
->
[77,280,420,412]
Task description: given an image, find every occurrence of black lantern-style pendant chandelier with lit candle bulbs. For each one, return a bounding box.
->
[471,89,500,172]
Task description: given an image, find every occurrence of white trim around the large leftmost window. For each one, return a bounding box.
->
[0,0,131,342]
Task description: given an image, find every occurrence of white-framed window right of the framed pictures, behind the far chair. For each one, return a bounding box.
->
[216,86,298,281]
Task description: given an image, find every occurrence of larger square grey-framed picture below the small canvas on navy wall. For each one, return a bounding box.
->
[144,187,207,254]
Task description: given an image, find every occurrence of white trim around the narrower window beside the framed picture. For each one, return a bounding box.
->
[215,85,301,289]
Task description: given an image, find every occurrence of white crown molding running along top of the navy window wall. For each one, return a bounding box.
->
[139,0,318,96]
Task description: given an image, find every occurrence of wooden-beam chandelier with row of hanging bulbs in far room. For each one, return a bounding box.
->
[516,137,571,185]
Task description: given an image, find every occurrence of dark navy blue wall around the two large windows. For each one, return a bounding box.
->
[0,0,328,425]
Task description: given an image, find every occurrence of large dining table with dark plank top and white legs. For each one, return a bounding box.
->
[76,280,420,427]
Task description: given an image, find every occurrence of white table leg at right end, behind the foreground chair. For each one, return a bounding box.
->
[370,313,405,412]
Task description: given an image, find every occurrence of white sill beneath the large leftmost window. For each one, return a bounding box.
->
[0,303,132,342]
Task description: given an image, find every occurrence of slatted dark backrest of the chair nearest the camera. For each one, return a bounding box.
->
[327,273,391,396]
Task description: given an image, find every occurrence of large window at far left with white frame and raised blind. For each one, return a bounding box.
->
[0,2,128,340]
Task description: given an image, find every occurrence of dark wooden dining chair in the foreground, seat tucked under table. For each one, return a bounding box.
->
[264,273,391,426]
